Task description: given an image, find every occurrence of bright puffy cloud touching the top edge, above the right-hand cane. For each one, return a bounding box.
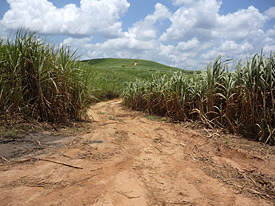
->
[161,0,267,41]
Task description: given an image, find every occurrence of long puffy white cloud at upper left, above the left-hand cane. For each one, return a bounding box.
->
[1,0,130,37]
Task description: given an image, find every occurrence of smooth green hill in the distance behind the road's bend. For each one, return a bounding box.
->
[82,58,193,100]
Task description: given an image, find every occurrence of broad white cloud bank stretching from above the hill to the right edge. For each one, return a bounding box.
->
[62,0,275,69]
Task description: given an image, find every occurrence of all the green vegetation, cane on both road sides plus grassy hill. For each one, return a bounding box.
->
[0,30,275,144]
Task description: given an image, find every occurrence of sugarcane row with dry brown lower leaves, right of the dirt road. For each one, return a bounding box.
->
[123,53,275,145]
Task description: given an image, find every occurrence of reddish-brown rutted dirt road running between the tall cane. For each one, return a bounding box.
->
[0,99,275,206]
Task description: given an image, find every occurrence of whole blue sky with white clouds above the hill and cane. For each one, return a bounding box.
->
[0,0,275,70]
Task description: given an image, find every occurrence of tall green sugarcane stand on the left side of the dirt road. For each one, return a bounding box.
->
[0,30,92,122]
